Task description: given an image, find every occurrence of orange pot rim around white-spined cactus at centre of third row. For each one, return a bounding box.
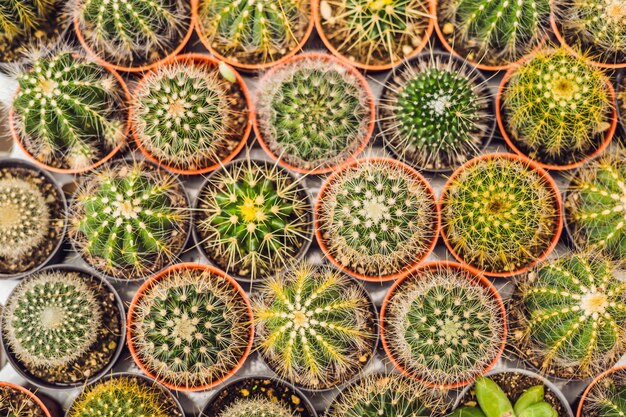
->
[315,158,441,282]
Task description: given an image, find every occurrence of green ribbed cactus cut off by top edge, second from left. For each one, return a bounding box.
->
[74,0,191,67]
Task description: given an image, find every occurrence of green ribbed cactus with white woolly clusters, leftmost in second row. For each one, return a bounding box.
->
[12,50,126,171]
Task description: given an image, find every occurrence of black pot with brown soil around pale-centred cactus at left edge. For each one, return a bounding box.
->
[0,159,67,280]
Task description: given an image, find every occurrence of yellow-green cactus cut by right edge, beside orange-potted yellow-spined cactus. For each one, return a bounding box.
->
[565,150,626,262]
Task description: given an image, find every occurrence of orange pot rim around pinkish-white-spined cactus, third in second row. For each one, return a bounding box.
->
[253,52,376,175]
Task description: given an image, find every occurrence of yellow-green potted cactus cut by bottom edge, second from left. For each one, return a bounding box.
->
[65,373,185,417]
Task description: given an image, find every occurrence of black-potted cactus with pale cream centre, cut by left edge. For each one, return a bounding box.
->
[0,159,66,278]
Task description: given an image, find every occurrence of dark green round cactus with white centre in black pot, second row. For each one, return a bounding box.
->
[380,54,493,170]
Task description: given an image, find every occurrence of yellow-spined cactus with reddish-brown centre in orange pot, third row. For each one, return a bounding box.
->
[441,154,562,275]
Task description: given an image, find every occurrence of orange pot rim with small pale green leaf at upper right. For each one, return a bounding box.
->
[128,54,253,175]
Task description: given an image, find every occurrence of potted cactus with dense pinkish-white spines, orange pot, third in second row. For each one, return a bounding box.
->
[254,53,375,174]
